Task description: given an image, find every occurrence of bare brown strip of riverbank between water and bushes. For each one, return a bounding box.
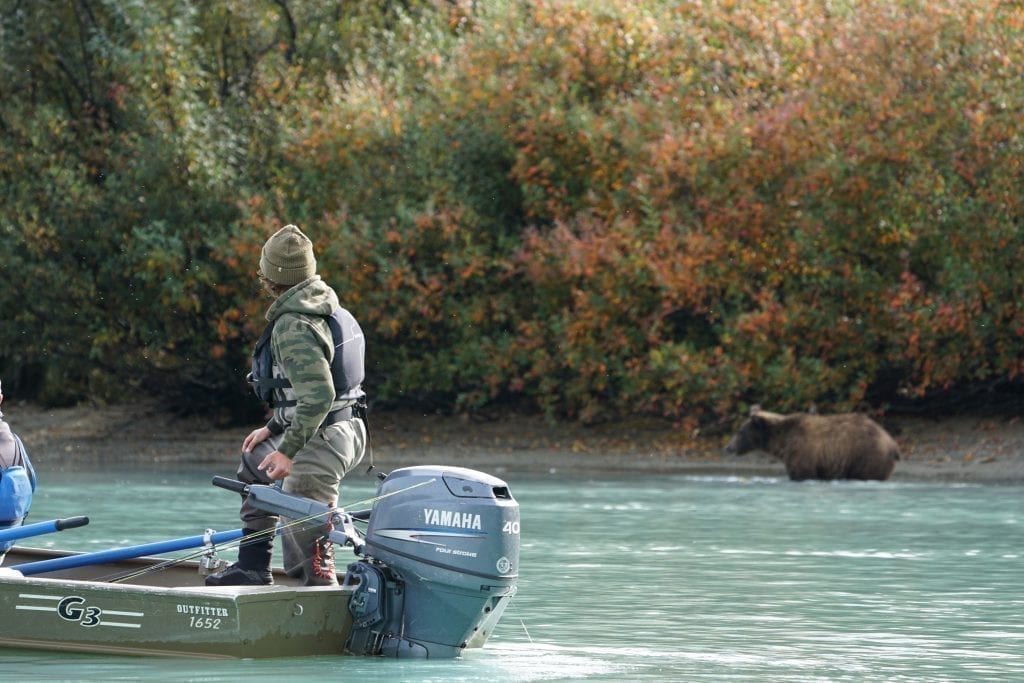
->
[4,401,1024,484]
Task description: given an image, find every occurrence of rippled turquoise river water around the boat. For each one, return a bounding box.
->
[0,468,1024,683]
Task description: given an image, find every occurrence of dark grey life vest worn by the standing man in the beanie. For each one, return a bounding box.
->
[248,307,367,408]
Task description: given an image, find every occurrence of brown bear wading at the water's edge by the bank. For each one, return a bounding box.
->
[725,408,899,481]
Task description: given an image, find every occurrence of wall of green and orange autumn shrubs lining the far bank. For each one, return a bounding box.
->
[0,0,1024,426]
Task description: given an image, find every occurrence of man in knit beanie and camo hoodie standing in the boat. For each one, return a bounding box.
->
[206,225,367,586]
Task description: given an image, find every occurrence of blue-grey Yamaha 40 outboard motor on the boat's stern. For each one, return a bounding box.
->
[345,466,519,658]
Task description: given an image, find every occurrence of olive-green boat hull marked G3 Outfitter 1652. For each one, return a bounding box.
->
[0,548,354,658]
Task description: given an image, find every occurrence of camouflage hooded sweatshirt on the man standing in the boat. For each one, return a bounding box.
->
[266,275,352,458]
